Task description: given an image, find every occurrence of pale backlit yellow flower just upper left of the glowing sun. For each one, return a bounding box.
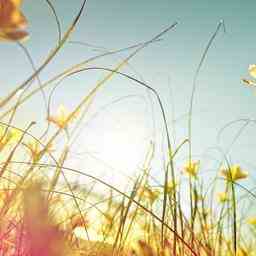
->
[48,105,75,129]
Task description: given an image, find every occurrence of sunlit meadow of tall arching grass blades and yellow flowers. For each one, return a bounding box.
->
[0,0,256,256]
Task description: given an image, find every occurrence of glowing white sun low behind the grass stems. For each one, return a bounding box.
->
[68,108,151,187]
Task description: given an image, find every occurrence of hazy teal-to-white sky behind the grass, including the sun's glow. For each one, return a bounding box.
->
[0,0,256,209]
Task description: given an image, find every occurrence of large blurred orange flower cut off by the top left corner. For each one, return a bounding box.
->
[0,0,28,41]
